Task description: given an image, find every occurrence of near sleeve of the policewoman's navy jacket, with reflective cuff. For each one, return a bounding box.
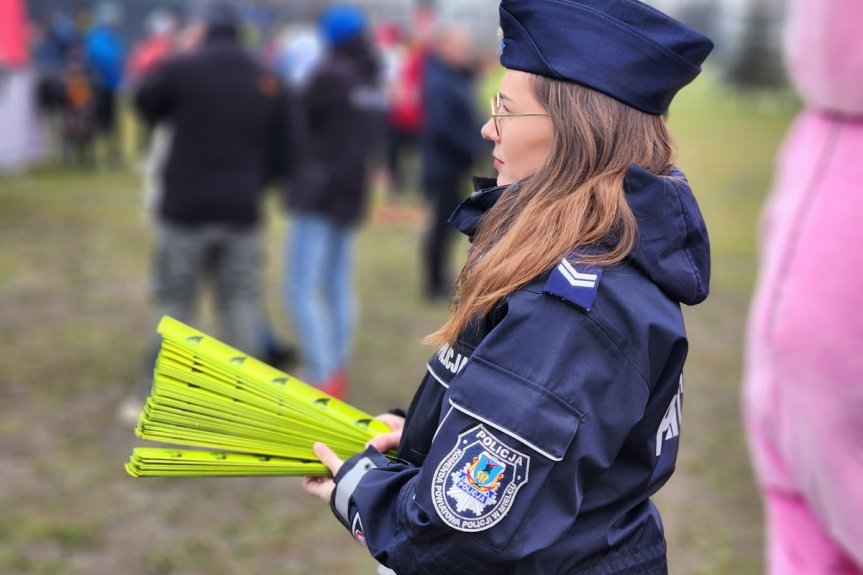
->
[334,294,649,575]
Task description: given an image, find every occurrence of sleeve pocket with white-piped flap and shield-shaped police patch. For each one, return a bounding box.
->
[411,356,582,565]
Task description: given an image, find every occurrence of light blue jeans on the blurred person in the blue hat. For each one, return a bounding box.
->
[284,214,356,385]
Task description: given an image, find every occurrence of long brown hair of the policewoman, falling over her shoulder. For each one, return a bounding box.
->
[425,76,674,344]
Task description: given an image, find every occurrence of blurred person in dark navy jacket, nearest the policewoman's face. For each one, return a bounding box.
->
[420,22,484,300]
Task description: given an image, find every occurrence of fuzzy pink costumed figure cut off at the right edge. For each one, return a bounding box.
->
[743,0,863,575]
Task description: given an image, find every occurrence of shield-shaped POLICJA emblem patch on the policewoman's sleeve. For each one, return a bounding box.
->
[432,425,530,531]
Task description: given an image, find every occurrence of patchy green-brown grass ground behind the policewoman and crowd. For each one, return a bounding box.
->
[0,73,793,575]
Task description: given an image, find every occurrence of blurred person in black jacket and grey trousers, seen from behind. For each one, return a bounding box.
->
[120,0,289,424]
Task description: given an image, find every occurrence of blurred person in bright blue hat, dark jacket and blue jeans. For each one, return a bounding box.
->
[284,5,384,397]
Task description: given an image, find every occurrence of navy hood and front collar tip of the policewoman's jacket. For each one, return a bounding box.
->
[450,165,710,305]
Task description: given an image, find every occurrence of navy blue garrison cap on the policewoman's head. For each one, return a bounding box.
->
[500,0,713,115]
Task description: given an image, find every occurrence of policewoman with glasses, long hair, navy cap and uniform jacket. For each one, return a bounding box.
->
[304,0,713,575]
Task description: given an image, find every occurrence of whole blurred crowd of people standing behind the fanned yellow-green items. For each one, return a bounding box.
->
[6,0,496,420]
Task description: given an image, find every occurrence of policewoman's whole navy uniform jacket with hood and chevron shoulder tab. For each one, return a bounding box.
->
[331,166,710,575]
